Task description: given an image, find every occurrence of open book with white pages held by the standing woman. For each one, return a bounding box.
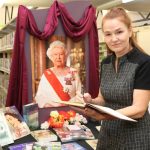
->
[58,101,137,122]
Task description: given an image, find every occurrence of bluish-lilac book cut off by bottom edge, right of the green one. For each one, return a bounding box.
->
[61,142,87,150]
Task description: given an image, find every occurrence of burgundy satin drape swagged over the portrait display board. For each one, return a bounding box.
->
[6,1,99,112]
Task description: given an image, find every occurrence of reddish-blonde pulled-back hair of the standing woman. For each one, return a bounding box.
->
[102,7,144,52]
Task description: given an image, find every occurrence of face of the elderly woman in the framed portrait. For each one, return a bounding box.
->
[51,47,66,67]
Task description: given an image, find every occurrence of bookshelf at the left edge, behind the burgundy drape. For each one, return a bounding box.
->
[0,19,15,107]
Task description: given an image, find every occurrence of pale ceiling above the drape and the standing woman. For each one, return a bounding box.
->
[1,0,150,12]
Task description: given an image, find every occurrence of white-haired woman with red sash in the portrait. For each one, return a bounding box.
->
[35,41,82,107]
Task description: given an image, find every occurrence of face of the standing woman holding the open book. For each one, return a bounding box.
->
[103,18,132,57]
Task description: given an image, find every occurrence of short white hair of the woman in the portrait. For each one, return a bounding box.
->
[46,40,68,59]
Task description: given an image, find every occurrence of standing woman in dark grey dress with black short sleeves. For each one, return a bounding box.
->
[78,8,150,150]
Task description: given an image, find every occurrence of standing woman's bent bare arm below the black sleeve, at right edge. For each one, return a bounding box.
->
[117,89,150,119]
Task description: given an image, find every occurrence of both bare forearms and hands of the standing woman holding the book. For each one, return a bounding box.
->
[78,89,150,120]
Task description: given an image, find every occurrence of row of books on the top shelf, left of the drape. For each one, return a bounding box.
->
[0,32,15,51]
